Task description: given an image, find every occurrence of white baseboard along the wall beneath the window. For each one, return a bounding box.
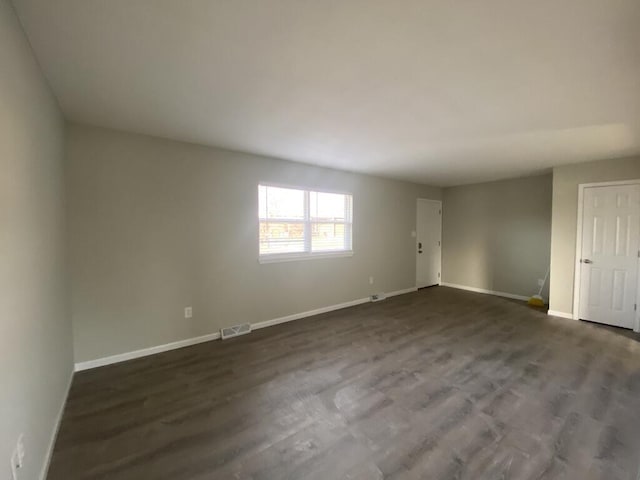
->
[75,287,418,372]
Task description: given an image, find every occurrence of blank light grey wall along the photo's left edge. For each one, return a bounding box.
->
[0,0,73,480]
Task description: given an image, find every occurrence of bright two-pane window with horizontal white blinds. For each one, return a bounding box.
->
[258,185,352,262]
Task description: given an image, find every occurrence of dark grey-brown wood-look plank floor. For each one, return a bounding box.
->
[48,287,640,480]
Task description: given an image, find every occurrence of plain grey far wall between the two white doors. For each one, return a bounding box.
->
[442,174,551,299]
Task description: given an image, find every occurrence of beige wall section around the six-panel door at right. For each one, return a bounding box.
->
[549,157,640,315]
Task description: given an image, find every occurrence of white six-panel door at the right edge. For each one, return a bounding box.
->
[579,185,640,328]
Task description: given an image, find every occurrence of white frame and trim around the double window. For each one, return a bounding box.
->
[256,182,353,263]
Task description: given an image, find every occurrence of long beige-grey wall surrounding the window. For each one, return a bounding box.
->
[68,125,441,362]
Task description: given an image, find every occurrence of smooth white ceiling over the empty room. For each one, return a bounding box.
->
[14,0,640,186]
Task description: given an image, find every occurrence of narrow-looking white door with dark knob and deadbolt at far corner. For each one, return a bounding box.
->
[416,199,442,288]
